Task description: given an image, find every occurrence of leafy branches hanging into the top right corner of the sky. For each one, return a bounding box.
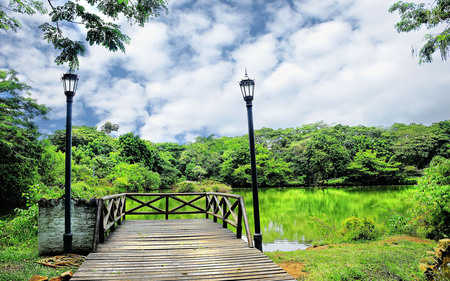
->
[389,0,450,64]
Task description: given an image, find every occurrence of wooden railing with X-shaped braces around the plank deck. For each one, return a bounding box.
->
[94,192,253,248]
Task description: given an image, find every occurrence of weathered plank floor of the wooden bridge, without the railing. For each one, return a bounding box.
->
[71,219,295,281]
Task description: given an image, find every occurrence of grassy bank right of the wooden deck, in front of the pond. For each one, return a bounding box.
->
[266,236,433,280]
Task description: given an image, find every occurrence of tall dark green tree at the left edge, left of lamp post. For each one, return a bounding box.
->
[0,70,49,205]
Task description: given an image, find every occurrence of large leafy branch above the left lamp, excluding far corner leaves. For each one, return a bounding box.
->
[39,0,166,69]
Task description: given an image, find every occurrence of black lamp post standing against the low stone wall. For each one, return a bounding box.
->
[61,70,78,253]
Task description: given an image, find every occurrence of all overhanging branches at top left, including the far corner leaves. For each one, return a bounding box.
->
[0,0,167,69]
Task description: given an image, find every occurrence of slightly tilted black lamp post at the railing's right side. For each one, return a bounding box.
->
[239,69,263,252]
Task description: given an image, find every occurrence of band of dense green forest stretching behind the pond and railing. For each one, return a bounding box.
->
[0,116,450,205]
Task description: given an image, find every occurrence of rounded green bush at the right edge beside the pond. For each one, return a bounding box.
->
[413,157,450,239]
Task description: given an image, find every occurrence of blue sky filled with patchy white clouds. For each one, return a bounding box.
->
[0,0,450,143]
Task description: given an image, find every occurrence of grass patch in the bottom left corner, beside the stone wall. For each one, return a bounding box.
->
[0,238,74,281]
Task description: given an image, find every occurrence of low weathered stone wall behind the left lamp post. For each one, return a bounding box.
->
[38,198,97,256]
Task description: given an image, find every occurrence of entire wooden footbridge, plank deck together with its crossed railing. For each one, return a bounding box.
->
[71,192,294,281]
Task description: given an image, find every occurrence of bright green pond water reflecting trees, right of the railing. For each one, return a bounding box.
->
[233,186,414,250]
